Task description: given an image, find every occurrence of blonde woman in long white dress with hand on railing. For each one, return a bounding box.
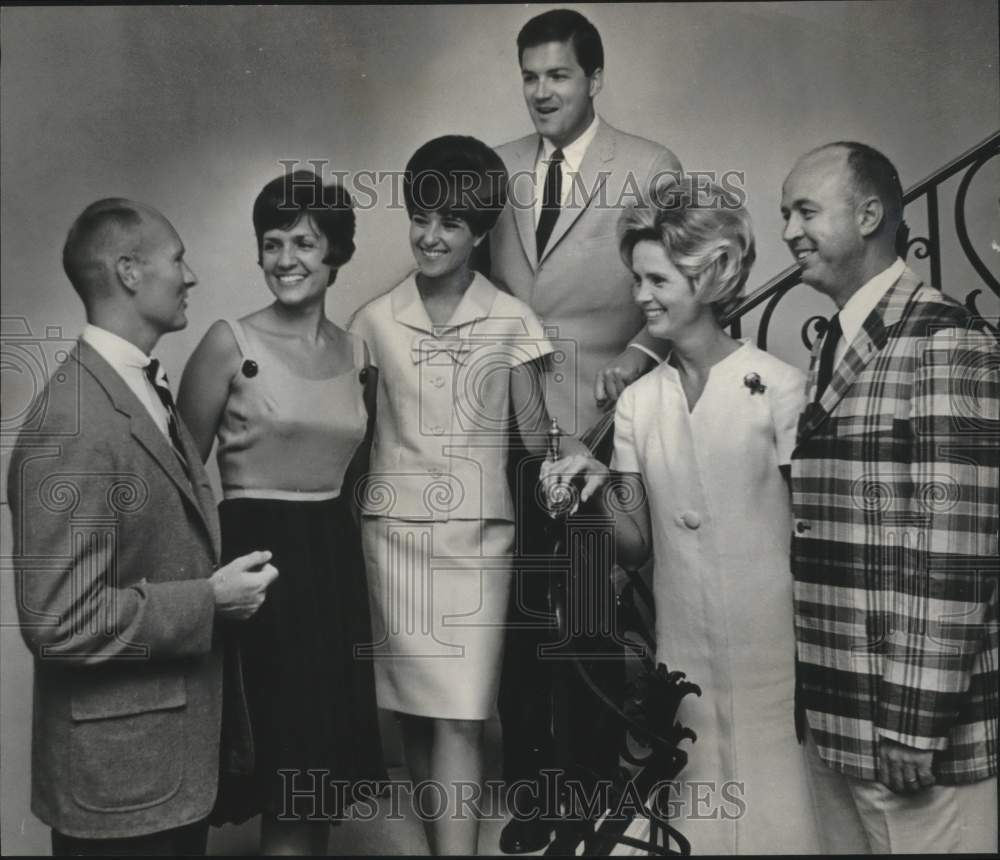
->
[543,185,818,854]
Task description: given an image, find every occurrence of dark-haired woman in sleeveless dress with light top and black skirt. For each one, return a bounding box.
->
[179,171,383,854]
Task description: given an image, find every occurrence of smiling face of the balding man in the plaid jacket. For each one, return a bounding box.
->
[781,149,865,304]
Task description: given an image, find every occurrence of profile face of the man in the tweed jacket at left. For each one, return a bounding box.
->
[135,211,198,335]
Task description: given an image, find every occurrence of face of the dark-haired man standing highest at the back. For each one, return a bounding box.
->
[521,42,603,147]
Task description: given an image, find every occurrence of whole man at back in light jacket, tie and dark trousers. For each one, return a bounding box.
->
[488,9,681,853]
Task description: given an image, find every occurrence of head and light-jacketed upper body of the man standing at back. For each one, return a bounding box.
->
[489,9,681,434]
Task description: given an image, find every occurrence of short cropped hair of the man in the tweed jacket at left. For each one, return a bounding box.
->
[63,197,142,301]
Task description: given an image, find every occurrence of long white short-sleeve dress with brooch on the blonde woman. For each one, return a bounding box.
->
[612,342,818,854]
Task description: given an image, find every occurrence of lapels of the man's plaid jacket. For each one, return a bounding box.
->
[798,268,921,441]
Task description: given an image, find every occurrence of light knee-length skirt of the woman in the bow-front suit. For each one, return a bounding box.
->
[361,517,514,720]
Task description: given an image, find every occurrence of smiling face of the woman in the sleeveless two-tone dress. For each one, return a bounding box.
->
[260,216,333,306]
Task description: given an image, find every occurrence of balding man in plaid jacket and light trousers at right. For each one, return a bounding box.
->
[781,143,1000,853]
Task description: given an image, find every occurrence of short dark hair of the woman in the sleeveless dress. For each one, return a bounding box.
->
[253,170,355,272]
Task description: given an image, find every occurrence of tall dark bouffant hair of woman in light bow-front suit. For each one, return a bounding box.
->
[403,134,507,236]
